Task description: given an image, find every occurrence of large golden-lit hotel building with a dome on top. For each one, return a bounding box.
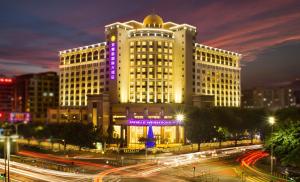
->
[59,14,241,146]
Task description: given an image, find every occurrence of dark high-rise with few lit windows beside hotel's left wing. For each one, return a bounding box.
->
[14,72,59,122]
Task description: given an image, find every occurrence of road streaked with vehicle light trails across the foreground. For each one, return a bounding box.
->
[0,145,278,182]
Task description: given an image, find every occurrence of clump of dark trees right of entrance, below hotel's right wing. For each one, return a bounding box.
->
[186,107,266,148]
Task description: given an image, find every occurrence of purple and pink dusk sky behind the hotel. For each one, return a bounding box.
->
[0,0,300,88]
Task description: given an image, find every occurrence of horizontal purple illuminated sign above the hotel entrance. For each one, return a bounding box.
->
[127,119,183,126]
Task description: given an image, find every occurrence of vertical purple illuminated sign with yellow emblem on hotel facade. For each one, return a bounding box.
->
[109,35,117,80]
